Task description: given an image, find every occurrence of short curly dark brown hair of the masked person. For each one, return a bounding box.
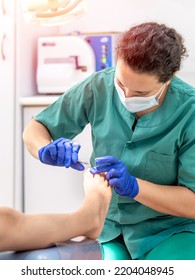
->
[116,22,188,83]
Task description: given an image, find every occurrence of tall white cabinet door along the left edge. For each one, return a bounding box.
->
[0,0,15,207]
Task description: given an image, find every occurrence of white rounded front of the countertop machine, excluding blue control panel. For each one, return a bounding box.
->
[36,36,95,94]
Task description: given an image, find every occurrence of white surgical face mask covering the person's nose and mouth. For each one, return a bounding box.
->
[114,80,166,113]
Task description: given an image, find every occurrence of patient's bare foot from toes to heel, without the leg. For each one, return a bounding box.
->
[82,170,112,239]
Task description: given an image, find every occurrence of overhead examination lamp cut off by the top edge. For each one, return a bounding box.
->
[21,0,86,26]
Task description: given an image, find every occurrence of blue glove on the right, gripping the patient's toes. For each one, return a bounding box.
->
[90,156,139,198]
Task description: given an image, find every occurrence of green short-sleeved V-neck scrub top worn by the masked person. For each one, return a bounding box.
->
[36,68,195,259]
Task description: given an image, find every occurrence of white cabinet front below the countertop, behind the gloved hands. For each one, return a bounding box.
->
[23,106,92,213]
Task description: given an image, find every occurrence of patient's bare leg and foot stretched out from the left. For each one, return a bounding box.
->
[0,171,111,251]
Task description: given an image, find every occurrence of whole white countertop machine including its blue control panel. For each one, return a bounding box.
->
[36,32,120,94]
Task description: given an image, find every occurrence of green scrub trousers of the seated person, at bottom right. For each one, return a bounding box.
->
[101,232,195,260]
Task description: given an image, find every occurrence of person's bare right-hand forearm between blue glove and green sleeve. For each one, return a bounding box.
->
[135,179,195,219]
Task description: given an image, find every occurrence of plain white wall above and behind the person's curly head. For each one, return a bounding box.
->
[60,0,195,86]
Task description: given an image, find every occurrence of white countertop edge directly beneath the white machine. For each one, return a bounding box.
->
[20,95,60,106]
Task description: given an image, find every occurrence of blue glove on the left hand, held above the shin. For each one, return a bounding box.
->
[38,138,85,171]
